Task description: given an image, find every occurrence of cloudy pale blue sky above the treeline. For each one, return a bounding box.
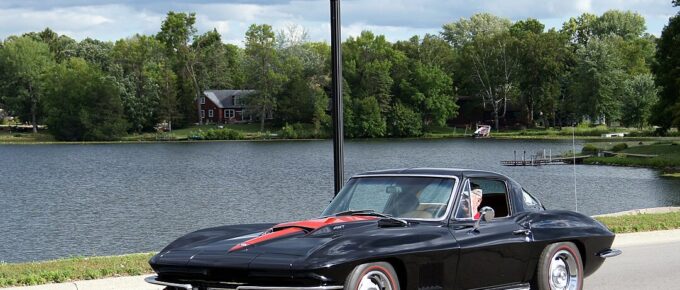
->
[0,0,679,46]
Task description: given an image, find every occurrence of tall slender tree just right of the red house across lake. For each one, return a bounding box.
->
[245,24,286,131]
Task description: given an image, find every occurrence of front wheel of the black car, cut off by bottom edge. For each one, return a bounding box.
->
[344,262,400,290]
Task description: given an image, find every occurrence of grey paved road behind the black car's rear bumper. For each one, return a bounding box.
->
[584,231,680,290]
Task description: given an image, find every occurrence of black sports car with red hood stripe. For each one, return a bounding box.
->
[146,168,621,290]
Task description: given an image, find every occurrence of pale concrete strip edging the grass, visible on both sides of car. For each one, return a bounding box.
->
[7,229,680,290]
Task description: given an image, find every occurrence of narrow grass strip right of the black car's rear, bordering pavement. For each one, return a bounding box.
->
[596,212,680,234]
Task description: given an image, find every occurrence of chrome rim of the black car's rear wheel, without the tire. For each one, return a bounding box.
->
[548,250,580,290]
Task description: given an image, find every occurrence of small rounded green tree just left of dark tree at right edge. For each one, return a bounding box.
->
[621,74,658,129]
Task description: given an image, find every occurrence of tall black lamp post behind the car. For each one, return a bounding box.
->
[330,0,345,195]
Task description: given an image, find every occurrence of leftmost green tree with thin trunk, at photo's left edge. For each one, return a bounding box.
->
[0,37,54,133]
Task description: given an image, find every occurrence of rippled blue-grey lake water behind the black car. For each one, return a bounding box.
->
[0,139,680,262]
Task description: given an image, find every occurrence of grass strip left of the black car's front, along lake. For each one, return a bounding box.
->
[0,253,153,287]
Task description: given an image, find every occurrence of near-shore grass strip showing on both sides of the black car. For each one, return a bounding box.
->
[0,212,680,287]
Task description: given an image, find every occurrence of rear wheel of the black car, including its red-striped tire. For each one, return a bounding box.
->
[532,242,583,290]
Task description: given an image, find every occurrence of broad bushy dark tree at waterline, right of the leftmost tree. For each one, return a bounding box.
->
[45,58,127,141]
